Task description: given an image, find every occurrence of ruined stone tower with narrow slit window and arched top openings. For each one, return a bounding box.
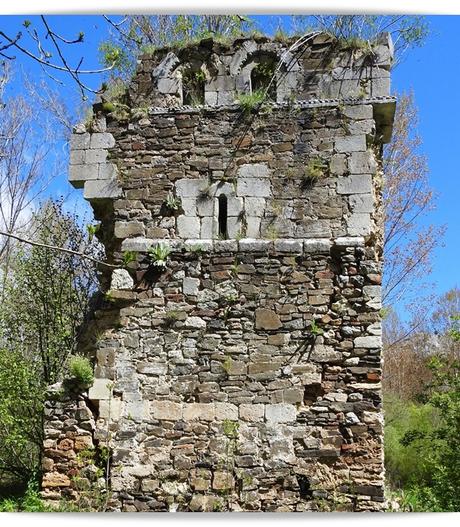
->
[43,34,395,511]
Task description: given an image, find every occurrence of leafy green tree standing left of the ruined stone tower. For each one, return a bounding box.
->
[0,202,100,486]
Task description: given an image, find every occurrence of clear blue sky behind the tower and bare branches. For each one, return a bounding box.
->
[0,15,460,314]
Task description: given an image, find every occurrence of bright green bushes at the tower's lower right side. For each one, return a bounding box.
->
[385,322,460,511]
